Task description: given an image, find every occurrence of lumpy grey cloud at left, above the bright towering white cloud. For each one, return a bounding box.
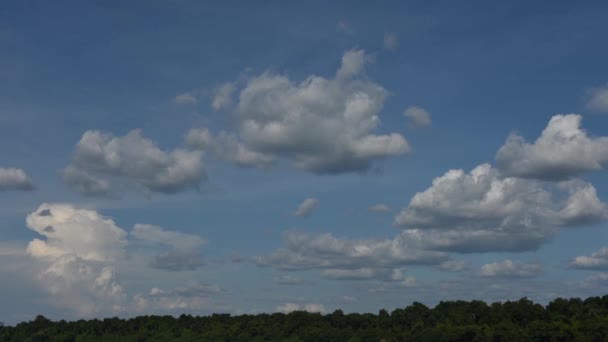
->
[63,130,205,196]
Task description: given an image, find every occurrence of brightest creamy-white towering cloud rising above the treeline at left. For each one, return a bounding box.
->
[26,204,127,316]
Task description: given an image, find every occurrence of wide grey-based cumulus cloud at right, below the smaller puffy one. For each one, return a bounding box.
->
[395,164,608,252]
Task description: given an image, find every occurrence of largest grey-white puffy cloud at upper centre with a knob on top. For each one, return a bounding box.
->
[189,50,410,173]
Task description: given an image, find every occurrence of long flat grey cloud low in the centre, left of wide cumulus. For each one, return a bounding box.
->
[253,232,448,272]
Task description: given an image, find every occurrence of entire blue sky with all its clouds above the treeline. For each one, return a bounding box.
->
[0,1,608,323]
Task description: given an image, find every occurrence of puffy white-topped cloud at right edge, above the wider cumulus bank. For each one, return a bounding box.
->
[496,114,608,180]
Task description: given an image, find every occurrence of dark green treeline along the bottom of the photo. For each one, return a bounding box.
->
[0,295,608,342]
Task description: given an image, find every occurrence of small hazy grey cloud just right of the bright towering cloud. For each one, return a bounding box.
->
[131,224,206,271]
